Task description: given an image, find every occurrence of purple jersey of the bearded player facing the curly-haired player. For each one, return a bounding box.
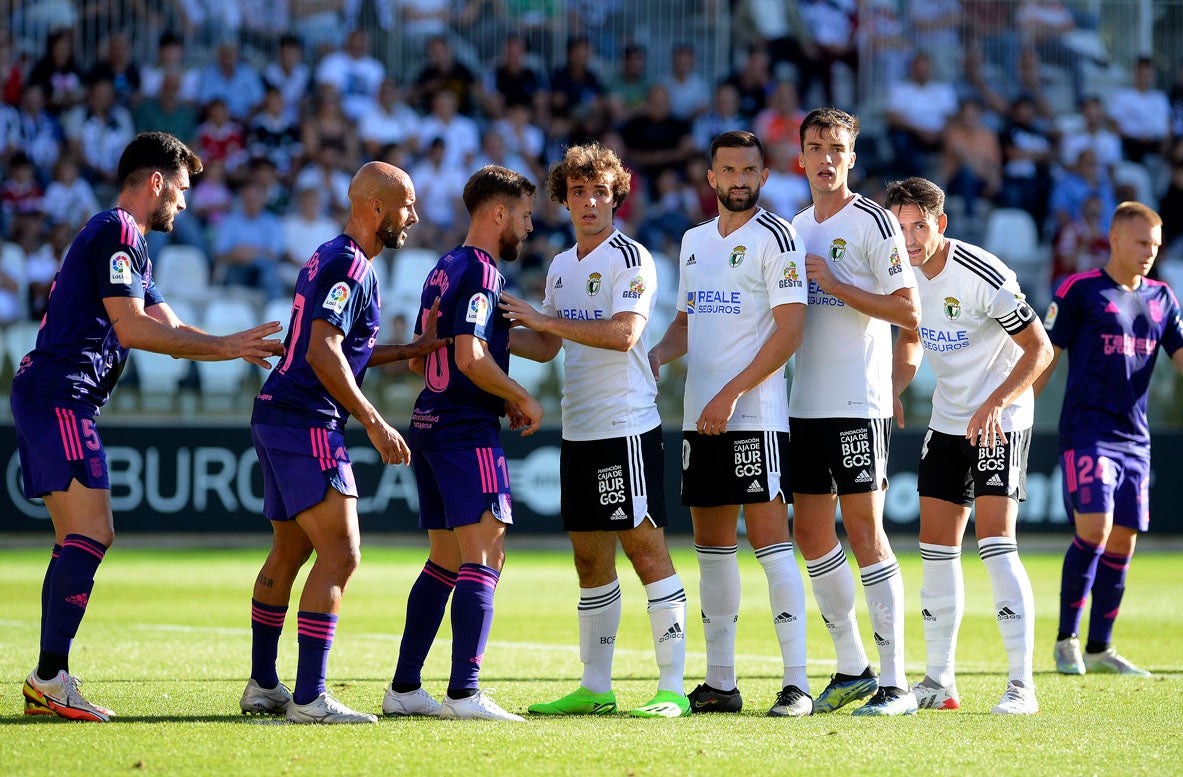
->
[407,246,510,451]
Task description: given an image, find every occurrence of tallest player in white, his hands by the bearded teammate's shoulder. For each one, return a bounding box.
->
[789,108,920,716]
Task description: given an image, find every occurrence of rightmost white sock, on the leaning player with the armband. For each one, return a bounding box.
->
[977,537,1035,688]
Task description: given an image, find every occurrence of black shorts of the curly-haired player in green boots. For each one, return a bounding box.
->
[558,427,666,531]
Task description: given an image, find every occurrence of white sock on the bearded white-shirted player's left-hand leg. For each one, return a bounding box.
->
[694,544,739,691]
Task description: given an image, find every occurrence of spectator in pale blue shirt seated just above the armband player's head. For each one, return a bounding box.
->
[886,51,957,177]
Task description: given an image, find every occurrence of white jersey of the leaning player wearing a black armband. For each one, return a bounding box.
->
[916,240,1035,436]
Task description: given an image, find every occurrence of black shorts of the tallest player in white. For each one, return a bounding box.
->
[789,419,892,494]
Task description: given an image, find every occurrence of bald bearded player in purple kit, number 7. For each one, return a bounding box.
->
[240,162,444,724]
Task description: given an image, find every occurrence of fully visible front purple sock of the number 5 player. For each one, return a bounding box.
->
[37,535,106,680]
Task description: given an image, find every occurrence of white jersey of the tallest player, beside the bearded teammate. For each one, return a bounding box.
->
[789,194,916,419]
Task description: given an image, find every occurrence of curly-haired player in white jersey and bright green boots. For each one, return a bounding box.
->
[502,143,690,718]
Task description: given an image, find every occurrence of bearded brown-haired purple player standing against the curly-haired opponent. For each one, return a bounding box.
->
[382,164,542,720]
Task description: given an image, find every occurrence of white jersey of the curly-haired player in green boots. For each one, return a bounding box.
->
[542,231,661,440]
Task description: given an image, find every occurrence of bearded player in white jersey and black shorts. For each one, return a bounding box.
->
[649,131,813,718]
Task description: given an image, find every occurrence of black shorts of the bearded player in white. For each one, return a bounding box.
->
[681,432,790,507]
